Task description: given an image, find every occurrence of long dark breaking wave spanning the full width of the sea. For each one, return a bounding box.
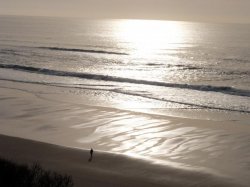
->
[0,64,250,97]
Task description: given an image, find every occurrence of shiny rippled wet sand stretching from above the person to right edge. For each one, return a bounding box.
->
[73,111,250,182]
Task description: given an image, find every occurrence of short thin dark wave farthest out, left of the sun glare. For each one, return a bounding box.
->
[38,47,129,55]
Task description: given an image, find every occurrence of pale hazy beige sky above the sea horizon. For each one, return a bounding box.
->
[0,0,250,23]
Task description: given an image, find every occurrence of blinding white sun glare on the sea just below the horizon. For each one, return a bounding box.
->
[116,20,186,57]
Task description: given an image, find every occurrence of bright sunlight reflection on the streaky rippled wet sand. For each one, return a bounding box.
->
[73,106,239,170]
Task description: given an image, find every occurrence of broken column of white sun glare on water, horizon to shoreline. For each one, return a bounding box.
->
[110,20,188,110]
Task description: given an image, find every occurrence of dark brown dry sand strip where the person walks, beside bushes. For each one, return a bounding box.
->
[0,135,243,187]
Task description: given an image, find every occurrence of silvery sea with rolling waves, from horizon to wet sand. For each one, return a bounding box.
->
[0,17,250,117]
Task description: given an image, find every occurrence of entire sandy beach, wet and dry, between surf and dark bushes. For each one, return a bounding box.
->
[0,81,249,187]
